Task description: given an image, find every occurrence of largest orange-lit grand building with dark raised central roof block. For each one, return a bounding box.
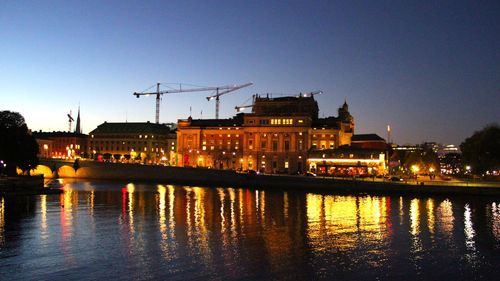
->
[177,95,354,173]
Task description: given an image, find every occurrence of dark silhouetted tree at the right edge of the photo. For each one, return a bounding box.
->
[460,125,500,174]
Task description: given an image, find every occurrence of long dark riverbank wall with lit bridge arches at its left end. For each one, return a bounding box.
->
[33,161,500,196]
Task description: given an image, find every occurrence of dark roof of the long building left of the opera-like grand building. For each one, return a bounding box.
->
[90,122,170,134]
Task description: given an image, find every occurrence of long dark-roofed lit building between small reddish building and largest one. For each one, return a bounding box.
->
[89,122,177,165]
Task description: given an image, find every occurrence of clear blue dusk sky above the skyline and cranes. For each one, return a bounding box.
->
[0,0,500,144]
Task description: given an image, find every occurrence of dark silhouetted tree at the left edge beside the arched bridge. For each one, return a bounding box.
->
[0,111,38,175]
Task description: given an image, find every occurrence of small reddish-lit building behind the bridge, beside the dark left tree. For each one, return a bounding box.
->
[33,131,87,159]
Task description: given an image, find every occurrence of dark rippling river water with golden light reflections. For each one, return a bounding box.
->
[0,182,500,280]
